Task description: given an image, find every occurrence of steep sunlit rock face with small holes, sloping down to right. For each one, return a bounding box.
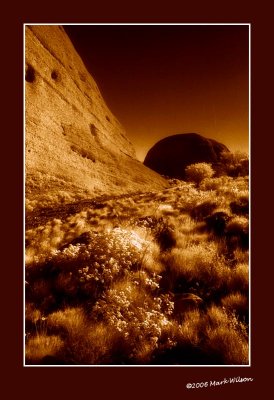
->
[25,25,167,209]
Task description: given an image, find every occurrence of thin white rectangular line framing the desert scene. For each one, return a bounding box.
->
[23,22,251,368]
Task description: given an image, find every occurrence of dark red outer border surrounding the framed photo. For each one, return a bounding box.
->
[4,0,273,400]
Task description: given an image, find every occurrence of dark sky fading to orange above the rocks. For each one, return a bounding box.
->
[64,25,249,161]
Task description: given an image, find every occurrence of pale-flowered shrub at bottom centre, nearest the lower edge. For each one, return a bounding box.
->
[92,282,173,363]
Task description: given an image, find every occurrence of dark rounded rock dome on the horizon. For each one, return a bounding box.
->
[144,133,229,179]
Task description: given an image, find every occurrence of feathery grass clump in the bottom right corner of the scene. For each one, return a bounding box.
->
[153,306,248,365]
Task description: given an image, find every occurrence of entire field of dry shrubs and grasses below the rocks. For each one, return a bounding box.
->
[25,160,249,365]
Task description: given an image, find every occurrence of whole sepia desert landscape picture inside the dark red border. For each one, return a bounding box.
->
[22,23,249,366]
